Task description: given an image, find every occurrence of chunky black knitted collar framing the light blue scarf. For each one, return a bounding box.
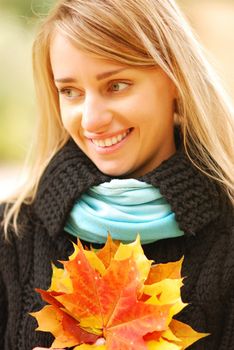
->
[33,140,223,236]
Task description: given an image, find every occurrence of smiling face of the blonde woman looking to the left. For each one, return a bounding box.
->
[50,34,176,177]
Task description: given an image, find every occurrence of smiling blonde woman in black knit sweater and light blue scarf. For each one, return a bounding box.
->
[0,0,234,350]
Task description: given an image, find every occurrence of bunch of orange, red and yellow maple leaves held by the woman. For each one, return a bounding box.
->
[31,235,207,350]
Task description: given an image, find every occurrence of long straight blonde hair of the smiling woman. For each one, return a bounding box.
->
[1,0,234,237]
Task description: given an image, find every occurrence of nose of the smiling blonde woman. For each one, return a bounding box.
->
[81,96,113,132]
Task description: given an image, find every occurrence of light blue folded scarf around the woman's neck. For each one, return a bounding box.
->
[64,179,184,244]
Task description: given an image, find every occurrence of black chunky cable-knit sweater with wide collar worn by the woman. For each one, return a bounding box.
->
[0,141,234,350]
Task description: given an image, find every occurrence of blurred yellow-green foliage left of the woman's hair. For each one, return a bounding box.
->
[0,0,54,162]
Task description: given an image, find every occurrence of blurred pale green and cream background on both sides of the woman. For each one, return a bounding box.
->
[0,0,234,199]
